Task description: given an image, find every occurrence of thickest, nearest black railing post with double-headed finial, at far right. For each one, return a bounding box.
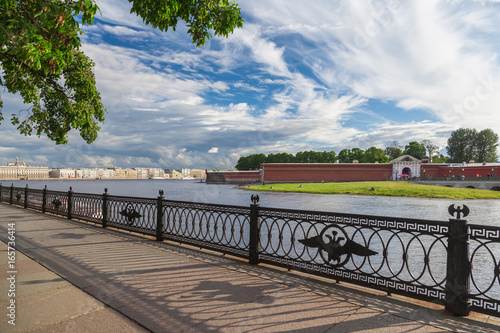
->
[445,205,471,316]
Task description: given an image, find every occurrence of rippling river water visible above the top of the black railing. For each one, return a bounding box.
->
[1,179,500,226]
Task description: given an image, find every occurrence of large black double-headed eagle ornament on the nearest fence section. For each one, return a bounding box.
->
[298,225,378,267]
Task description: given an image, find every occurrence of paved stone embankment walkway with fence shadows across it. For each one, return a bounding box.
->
[0,203,500,332]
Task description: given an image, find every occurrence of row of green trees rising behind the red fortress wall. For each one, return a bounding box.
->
[236,128,499,170]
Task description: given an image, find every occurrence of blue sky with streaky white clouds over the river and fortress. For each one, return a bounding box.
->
[0,0,500,169]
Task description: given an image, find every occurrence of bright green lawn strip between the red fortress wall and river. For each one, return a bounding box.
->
[245,181,500,199]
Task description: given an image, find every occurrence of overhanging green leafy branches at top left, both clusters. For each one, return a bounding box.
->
[0,0,243,144]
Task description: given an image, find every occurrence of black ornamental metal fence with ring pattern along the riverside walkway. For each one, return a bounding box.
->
[0,184,500,316]
